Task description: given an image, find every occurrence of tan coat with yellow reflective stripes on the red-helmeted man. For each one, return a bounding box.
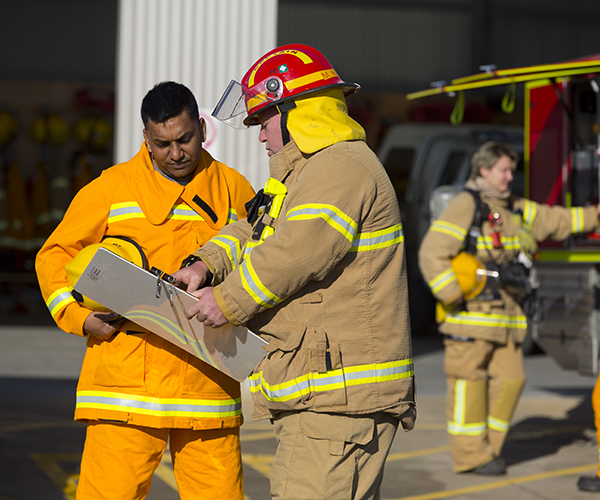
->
[197,141,415,429]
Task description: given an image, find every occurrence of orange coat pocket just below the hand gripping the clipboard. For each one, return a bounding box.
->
[94,332,148,389]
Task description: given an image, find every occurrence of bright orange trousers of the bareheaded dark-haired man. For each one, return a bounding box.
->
[77,422,244,500]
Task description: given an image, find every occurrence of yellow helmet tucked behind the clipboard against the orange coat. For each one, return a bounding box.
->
[65,236,148,312]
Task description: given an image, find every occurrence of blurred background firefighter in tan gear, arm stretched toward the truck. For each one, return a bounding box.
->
[419,142,598,475]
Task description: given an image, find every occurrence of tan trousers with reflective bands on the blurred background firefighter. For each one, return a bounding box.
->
[444,336,525,472]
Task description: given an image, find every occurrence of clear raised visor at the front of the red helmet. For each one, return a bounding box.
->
[212,76,284,129]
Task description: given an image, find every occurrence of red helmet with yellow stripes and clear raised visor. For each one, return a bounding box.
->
[213,44,360,127]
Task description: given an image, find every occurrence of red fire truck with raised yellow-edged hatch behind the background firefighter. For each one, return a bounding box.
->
[407,54,600,375]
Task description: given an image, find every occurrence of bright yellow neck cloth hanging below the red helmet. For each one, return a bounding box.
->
[287,88,367,154]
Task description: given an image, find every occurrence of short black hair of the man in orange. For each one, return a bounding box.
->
[142,82,200,128]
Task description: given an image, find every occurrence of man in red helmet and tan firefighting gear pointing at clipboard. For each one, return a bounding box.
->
[175,44,415,500]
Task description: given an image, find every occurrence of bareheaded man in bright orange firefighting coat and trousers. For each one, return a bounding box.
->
[36,82,254,500]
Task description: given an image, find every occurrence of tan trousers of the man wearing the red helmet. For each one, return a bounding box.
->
[270,411,399,500]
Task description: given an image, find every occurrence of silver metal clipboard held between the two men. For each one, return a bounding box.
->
[73,247,267,382]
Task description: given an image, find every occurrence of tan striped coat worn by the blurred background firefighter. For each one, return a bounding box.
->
[419,191,597,344]
